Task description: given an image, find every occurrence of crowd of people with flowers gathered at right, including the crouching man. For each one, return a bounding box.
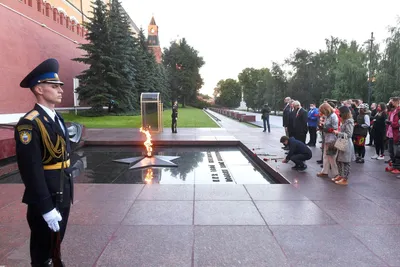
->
[280,97,400,185]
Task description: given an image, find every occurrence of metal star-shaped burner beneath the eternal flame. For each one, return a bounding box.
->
[114,155,179,169]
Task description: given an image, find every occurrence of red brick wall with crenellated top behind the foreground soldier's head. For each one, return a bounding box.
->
[0,0,86,114]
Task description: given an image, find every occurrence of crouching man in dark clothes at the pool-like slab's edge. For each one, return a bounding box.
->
[280,136,312,171]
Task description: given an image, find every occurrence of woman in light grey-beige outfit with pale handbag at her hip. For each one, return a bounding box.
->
[332,106,355,185]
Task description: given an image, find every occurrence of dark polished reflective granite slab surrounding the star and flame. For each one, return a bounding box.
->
[0,146,277,184]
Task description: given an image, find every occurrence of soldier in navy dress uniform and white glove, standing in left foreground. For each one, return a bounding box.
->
[15,58,73,266]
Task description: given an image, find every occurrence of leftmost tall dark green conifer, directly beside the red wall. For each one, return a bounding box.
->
[73,0,112,114]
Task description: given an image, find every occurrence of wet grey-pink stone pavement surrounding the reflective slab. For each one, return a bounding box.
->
[0,110,400,267]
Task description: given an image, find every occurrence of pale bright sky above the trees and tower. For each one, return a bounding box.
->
[121,0,400,96]
